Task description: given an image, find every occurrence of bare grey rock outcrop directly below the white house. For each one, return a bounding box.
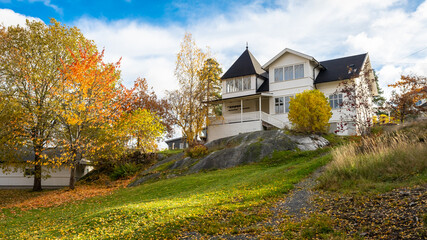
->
[129,130,329,186]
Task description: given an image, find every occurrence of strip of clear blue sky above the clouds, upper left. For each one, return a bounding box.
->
[0,0,274,25]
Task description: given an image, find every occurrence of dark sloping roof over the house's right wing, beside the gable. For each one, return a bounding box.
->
[314,53,367,84]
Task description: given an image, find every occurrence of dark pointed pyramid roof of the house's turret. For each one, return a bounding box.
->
[221,48,265,79]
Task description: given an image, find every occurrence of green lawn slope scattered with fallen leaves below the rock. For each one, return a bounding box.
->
[0,149,331,239]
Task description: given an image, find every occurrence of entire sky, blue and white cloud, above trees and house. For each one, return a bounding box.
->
[0,0,427,99]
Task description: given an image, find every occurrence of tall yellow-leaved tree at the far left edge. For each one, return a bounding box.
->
[0,20,90,191]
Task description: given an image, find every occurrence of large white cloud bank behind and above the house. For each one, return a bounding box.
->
[0,0,427,99]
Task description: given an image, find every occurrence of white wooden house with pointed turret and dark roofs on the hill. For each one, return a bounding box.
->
[207,48,377,142]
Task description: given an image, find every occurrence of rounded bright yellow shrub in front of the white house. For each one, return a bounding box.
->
[288,89,332,133]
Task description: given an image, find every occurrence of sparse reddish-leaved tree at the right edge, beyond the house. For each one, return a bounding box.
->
[388,74,427,123]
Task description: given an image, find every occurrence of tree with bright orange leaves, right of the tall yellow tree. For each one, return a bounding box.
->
[56,42,121,189]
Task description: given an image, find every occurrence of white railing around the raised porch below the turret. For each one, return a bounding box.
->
[209,111,285,128]
